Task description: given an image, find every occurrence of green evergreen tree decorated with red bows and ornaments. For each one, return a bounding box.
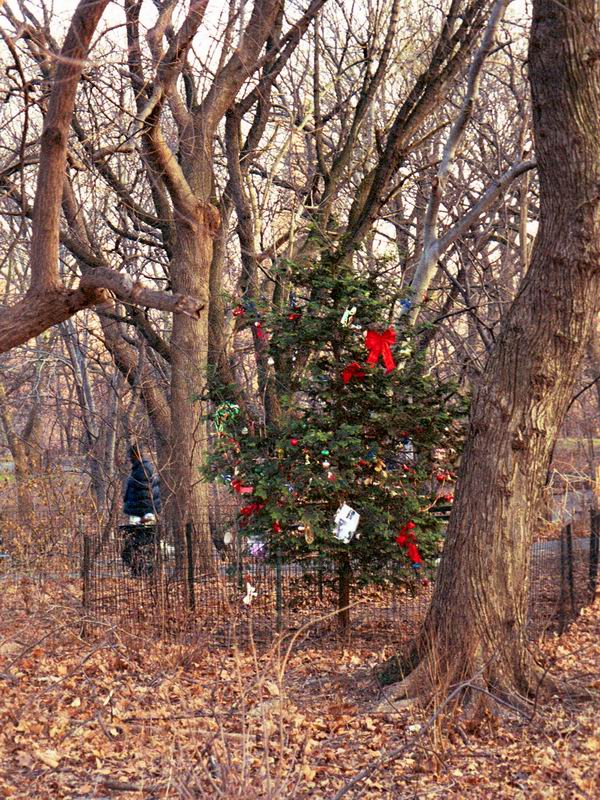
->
[210,264,465,620]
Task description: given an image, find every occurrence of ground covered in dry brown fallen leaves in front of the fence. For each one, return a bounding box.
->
[0,580,600,800]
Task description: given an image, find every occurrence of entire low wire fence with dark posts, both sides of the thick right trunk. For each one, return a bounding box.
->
[76,512,600,642]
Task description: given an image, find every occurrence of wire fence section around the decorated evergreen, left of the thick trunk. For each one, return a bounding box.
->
[82,529,433,643]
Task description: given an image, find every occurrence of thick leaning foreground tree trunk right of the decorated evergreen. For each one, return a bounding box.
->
[382,0,600,696]
